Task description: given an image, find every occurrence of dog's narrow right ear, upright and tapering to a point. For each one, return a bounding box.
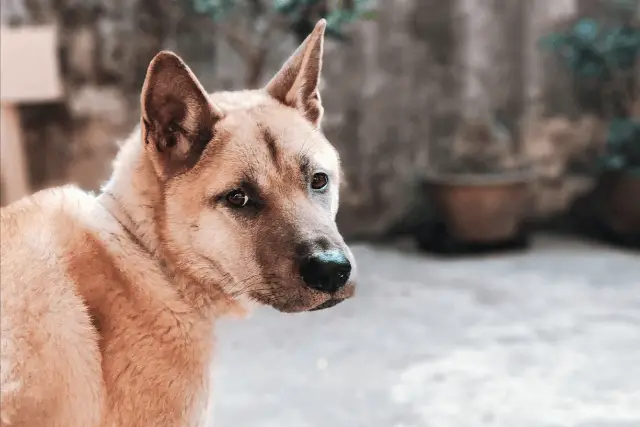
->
[265,19,327,126]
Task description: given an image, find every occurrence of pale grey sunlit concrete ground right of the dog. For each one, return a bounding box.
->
[214,238,640,427]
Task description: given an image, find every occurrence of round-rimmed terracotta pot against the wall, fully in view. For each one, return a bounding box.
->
[427,173,532,243]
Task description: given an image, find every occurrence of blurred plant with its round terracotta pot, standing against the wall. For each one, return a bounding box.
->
[418,115,533,252]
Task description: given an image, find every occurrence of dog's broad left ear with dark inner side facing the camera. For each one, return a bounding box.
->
[140,51,222,179]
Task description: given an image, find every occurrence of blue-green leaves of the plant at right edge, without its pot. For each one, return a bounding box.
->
[541,4,640,175]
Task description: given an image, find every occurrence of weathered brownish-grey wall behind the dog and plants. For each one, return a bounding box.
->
[2,0,620,236]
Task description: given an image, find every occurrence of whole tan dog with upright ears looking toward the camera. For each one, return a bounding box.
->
[0,21,355,427]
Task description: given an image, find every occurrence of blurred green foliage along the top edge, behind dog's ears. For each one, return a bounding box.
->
[192,0,375,87]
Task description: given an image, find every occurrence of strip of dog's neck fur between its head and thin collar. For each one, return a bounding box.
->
[99,130,246,317]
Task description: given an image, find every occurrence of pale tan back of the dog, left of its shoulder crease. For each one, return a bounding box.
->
[0,188,102,427]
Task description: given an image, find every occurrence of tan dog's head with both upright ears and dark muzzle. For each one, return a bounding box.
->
[141,21,355,312]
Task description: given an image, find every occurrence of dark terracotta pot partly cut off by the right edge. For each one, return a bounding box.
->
[596,170,640,235]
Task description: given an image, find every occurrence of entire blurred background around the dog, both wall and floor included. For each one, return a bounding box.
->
[0,0,640,427]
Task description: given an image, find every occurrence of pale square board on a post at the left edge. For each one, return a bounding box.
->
[0,25,63,203]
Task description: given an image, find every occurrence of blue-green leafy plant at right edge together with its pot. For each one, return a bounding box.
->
[543,8,640,243]
